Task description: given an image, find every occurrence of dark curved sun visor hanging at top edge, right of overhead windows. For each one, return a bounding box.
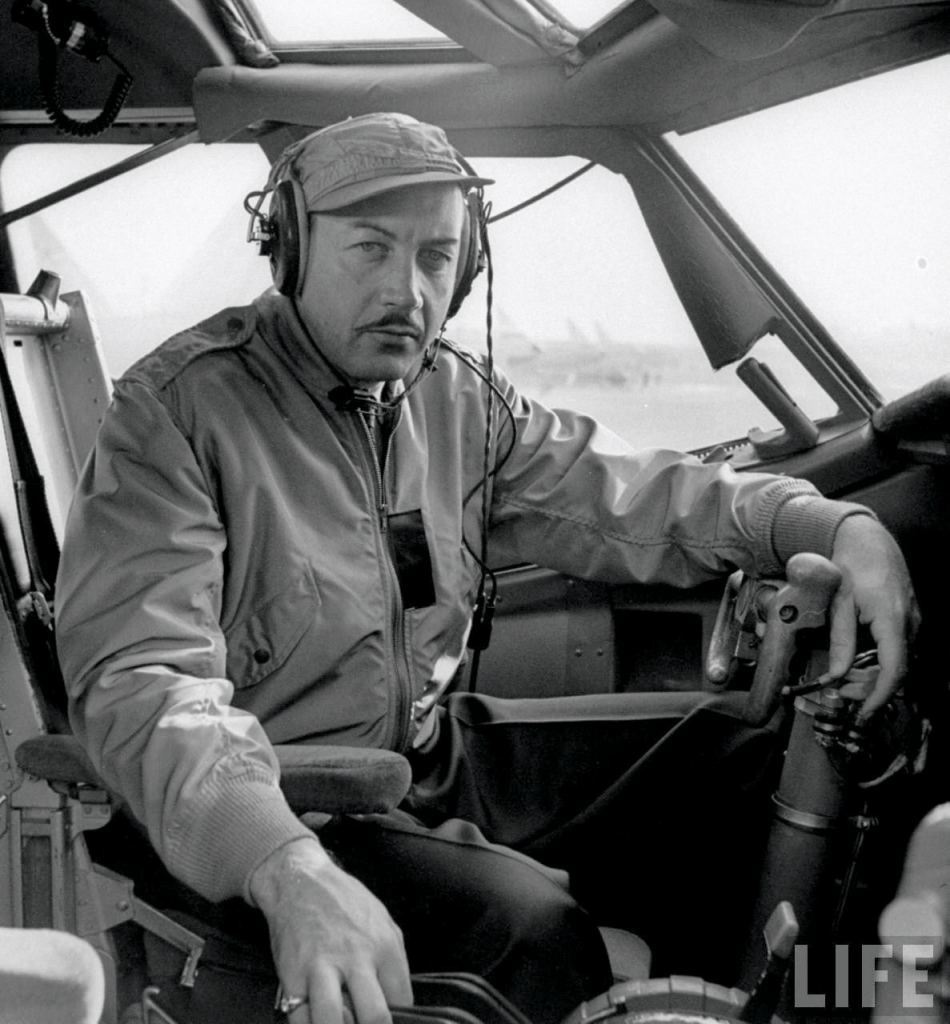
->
[650,0,847,60]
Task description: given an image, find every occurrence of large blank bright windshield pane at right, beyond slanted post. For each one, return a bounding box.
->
[672,56,950,398]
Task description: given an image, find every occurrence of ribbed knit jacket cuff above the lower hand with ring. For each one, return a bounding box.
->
[166,776,316,902]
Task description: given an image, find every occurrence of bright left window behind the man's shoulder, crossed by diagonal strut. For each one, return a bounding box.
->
[0,143,268,376]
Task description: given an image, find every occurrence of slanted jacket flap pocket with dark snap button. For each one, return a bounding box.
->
[225,569,320,689]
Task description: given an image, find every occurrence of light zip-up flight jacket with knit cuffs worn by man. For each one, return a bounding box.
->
[56,292,860,900]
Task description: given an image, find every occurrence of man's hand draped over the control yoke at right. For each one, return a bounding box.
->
[828,515,920,716]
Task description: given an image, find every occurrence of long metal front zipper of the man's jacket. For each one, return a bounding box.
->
[356,412,412,751]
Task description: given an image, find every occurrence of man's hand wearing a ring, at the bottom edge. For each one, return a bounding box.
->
[250,838,413,1024]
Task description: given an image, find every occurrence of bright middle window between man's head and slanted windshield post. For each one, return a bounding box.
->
[447,158,834,449]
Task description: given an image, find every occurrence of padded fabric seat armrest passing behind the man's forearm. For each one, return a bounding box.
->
[15,735,412,814]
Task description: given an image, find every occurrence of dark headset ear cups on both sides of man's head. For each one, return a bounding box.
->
[244,153,487,319]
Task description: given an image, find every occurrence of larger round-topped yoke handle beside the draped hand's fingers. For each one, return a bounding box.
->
[743,552,841,725]
